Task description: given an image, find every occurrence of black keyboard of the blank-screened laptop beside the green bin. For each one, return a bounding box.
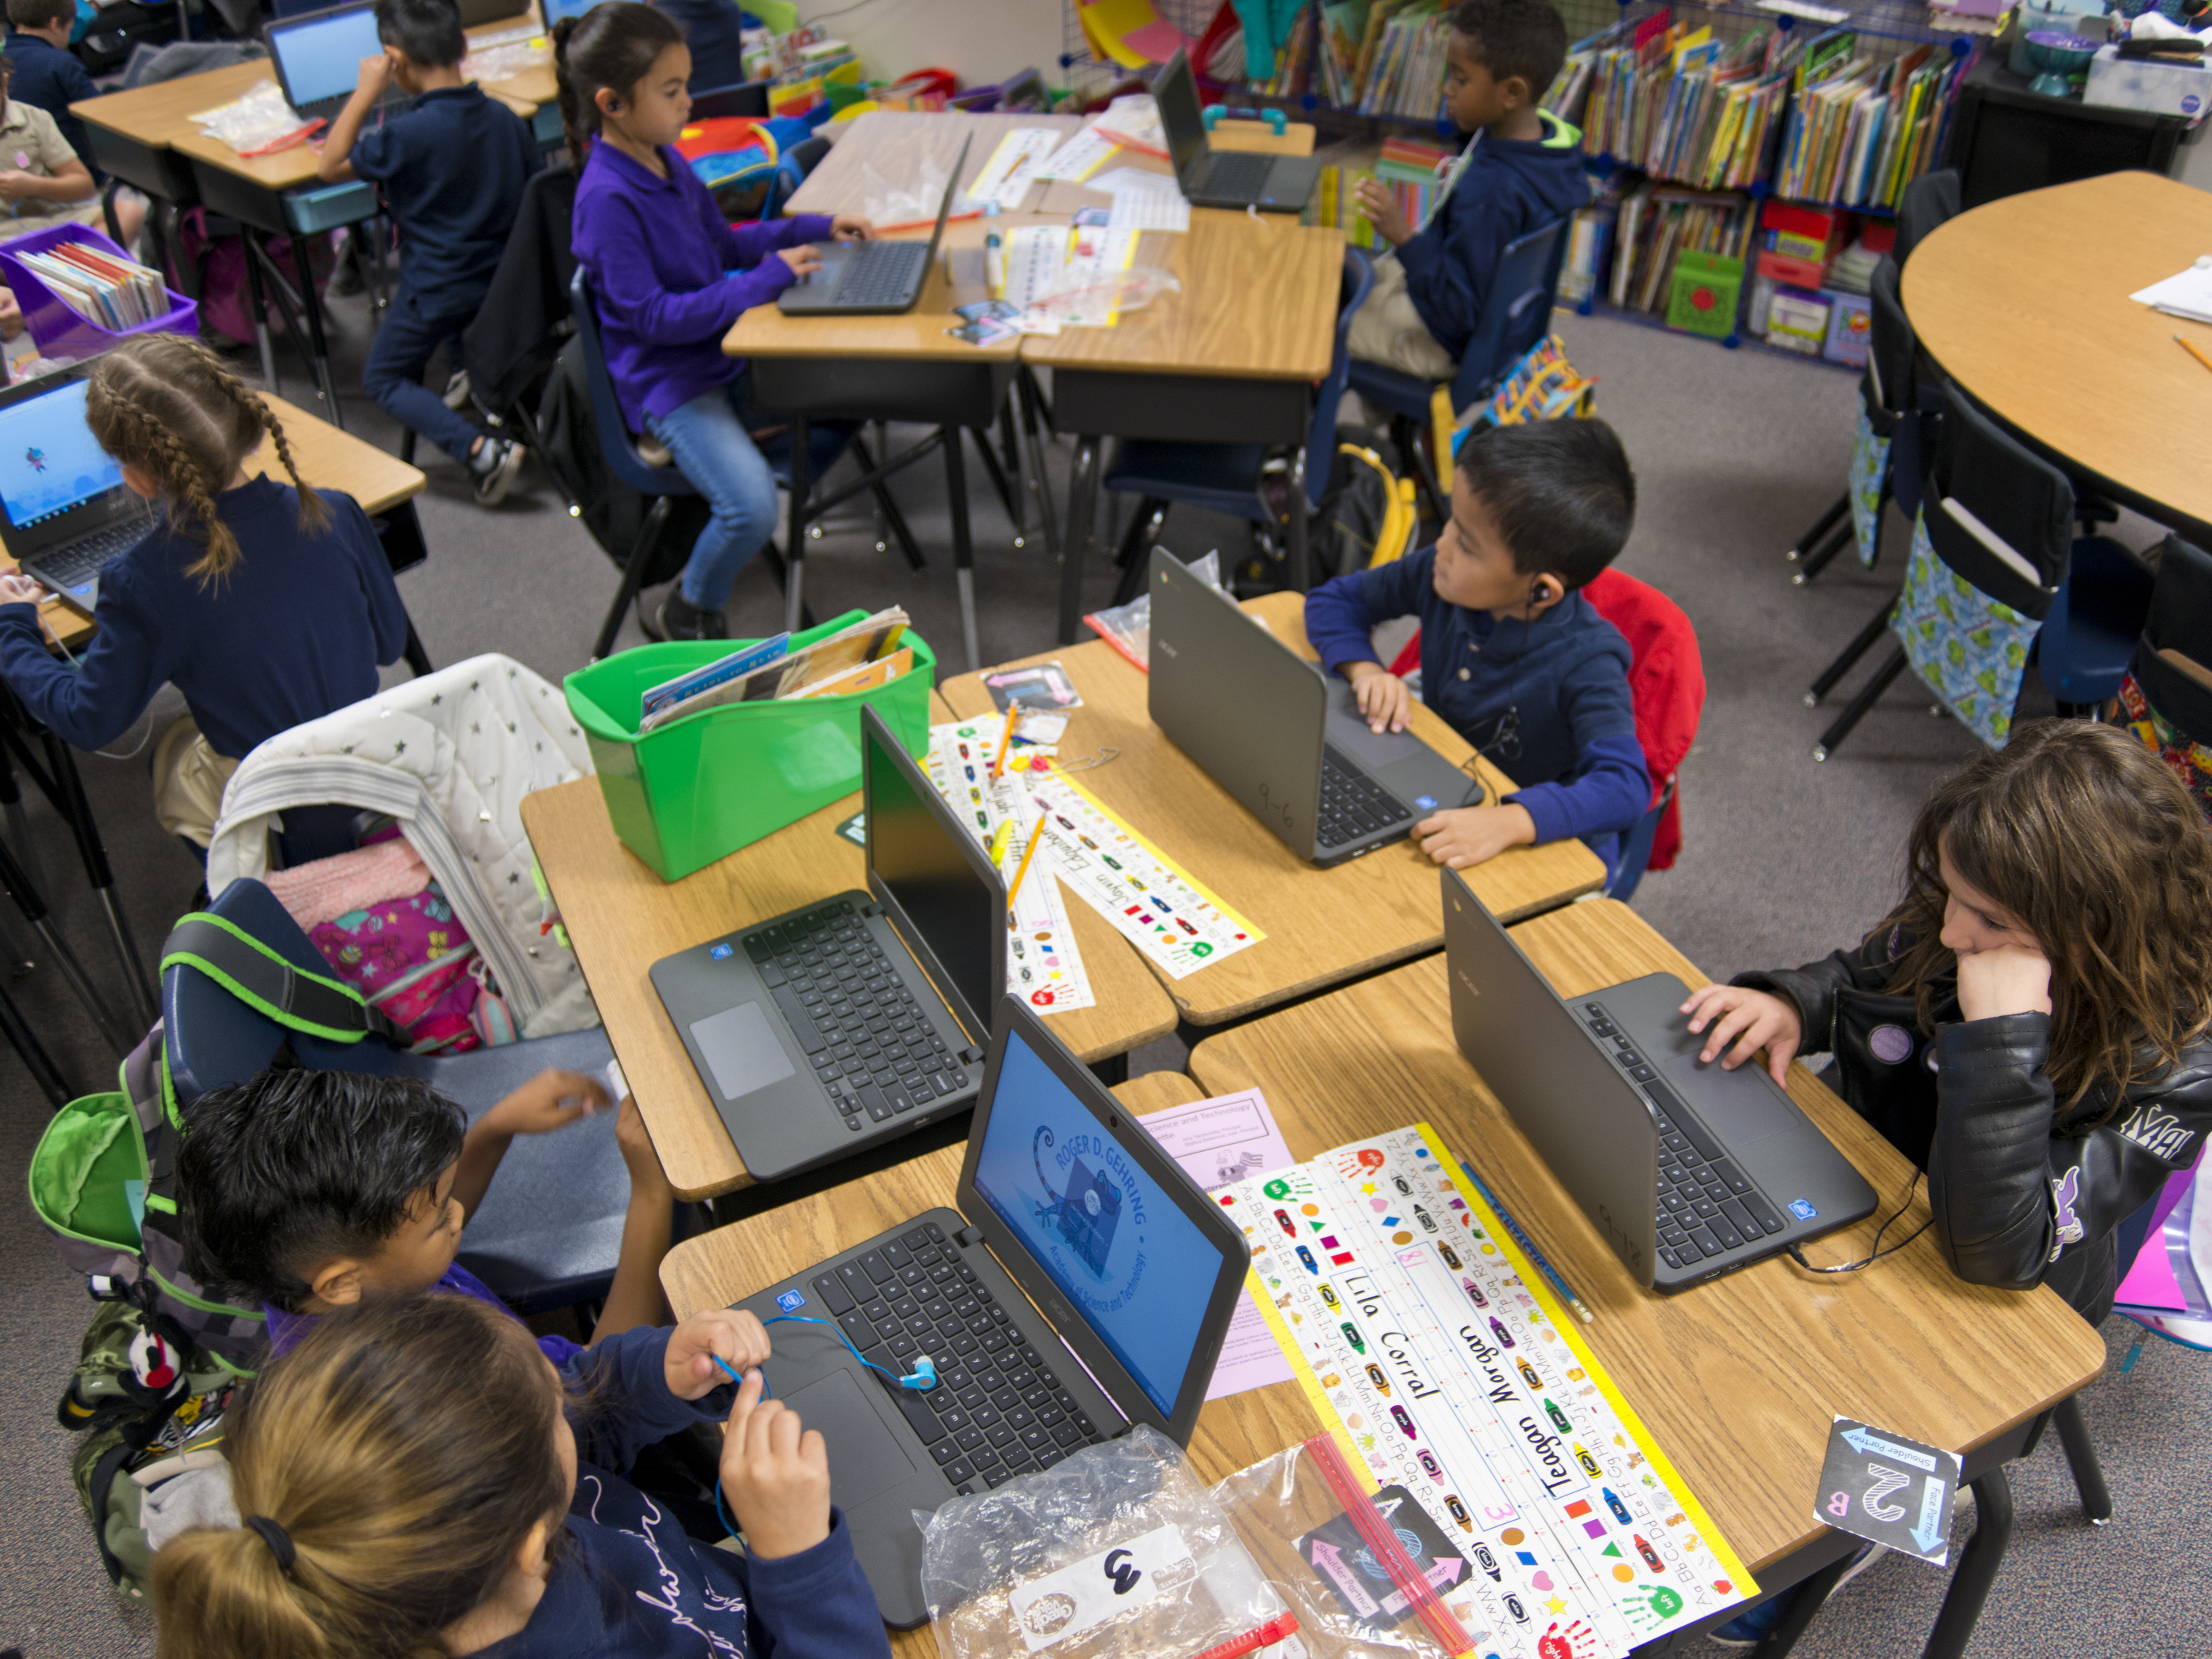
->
[743,898,973,1133]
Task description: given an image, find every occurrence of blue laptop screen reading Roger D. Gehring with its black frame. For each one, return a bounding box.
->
[973,1026,1221,1416]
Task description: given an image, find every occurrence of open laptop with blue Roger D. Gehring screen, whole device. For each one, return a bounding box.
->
[736,998,1250,1631]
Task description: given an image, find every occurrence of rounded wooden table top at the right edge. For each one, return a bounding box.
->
[1905,172,2212,533]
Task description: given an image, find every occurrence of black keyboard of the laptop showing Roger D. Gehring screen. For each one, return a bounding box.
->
[810,1221,1108,1493]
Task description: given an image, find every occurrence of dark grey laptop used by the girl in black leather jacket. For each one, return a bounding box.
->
[1443,869,1874,1292]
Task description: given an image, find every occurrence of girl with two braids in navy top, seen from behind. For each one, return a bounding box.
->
[0,334,407,849]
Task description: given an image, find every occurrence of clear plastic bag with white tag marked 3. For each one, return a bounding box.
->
[923,1424,1292,1659]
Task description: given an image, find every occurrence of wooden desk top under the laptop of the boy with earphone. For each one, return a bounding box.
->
[942,592,1606,1026]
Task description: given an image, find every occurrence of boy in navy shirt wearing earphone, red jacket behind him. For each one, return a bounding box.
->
[1305,420,1653,871]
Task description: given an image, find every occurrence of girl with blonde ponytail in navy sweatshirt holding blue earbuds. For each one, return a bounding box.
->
[152,1296,891,1659]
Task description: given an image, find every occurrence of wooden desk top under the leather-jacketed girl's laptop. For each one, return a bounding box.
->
[1190,901,2104,1573]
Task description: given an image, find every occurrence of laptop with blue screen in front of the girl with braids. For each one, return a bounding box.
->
[0,371,152,615]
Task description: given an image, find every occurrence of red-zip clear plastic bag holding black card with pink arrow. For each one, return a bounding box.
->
[1212,1433,1486,1659]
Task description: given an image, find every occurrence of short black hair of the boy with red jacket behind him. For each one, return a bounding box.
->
[1454,420,1637,592]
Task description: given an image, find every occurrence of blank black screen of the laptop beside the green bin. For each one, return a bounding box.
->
[860,708,1006,1042]
